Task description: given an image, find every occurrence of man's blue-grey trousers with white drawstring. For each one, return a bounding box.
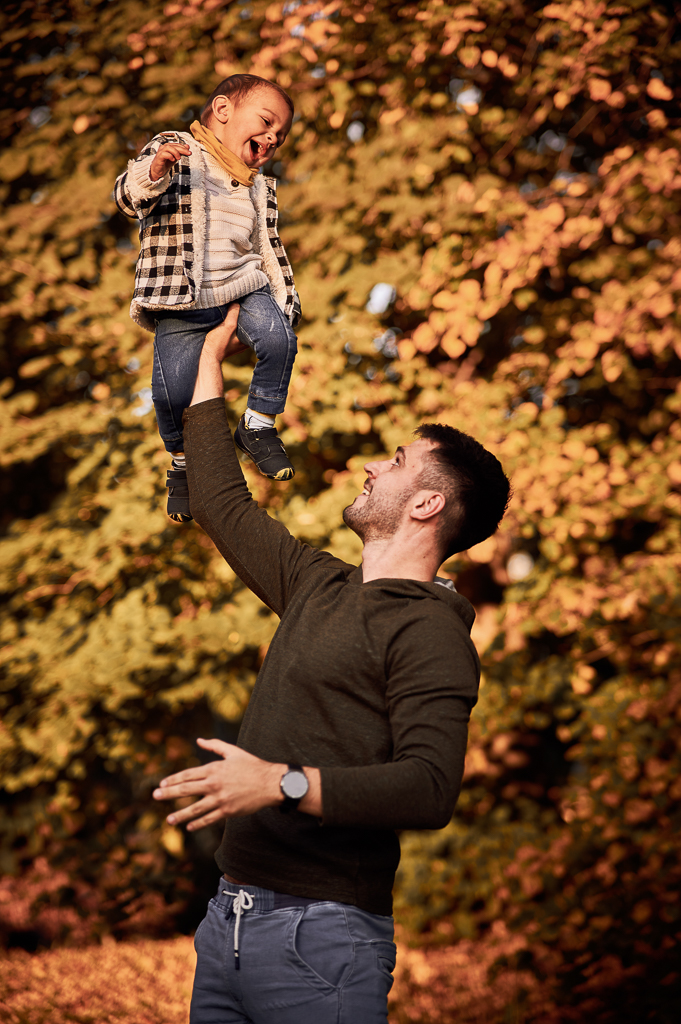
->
[189,880,395,1024]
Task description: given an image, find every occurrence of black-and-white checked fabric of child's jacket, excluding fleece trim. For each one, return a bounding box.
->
[114,131,300,328]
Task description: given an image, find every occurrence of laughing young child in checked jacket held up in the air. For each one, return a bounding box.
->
[114,75,300,522]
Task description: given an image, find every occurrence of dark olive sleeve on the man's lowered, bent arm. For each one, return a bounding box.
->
[321,603,479,829]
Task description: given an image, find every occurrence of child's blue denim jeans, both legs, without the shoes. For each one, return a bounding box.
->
[152,285,297,452]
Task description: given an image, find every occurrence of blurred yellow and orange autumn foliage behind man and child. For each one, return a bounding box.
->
[0,0,681,1022]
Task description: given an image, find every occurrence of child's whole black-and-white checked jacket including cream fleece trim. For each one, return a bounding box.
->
[114,131,300,331]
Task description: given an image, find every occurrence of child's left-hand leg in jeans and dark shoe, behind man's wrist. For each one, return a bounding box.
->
[152,309,223,522]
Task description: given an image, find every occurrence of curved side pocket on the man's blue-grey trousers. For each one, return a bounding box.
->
[293,903,354,988]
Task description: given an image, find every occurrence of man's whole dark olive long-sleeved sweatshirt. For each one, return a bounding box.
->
[184,398,479,914]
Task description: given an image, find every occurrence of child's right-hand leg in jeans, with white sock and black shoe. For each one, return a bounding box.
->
[235,286,298,480]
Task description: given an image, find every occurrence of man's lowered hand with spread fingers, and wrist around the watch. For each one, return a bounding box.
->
[154,739,322,831]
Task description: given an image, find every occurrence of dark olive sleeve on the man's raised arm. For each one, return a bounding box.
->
[184,398,344,616]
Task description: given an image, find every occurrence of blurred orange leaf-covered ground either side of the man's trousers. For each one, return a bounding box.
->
[0,935,543,1024]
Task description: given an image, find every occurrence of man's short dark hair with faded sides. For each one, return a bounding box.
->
[415,423,511,559]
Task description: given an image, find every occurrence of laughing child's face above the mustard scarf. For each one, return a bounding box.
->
[210,86,292,167]
